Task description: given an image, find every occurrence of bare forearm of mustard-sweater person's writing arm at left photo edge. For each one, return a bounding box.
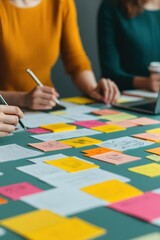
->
[0,91,27,107]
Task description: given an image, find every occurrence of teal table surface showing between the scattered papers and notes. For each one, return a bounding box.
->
[0,104,160,240]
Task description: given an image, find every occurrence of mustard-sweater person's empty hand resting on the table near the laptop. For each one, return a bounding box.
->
[89,78,120,104]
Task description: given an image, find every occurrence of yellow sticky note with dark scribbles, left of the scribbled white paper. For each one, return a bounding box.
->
[60,137,102,148]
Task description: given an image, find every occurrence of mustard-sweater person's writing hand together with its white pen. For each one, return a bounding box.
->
[26,69,60,110]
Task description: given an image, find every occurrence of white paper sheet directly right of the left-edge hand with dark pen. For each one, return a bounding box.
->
[23,113,70,128]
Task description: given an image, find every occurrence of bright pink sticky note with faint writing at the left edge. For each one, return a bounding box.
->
[0,182,43,200]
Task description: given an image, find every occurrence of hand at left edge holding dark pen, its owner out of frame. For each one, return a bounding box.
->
[0,105,23,137]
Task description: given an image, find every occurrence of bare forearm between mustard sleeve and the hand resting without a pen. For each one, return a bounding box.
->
[74,70,97,94]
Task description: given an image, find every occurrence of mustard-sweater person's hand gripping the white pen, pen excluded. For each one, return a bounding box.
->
[25,86,59,110]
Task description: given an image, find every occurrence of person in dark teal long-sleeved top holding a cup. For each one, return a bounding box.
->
[98,0,160,92]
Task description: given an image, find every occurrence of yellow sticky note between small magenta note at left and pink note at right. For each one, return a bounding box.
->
[40,123,76,132]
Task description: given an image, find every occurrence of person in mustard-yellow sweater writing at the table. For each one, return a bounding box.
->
[0,0,119,109]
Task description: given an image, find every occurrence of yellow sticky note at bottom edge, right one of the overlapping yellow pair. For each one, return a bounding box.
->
[26,218,106,240]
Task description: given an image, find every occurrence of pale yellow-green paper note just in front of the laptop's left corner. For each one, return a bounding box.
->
[100,112,137,121]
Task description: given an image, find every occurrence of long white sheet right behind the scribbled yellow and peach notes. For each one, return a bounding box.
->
[31,128,100,141]
